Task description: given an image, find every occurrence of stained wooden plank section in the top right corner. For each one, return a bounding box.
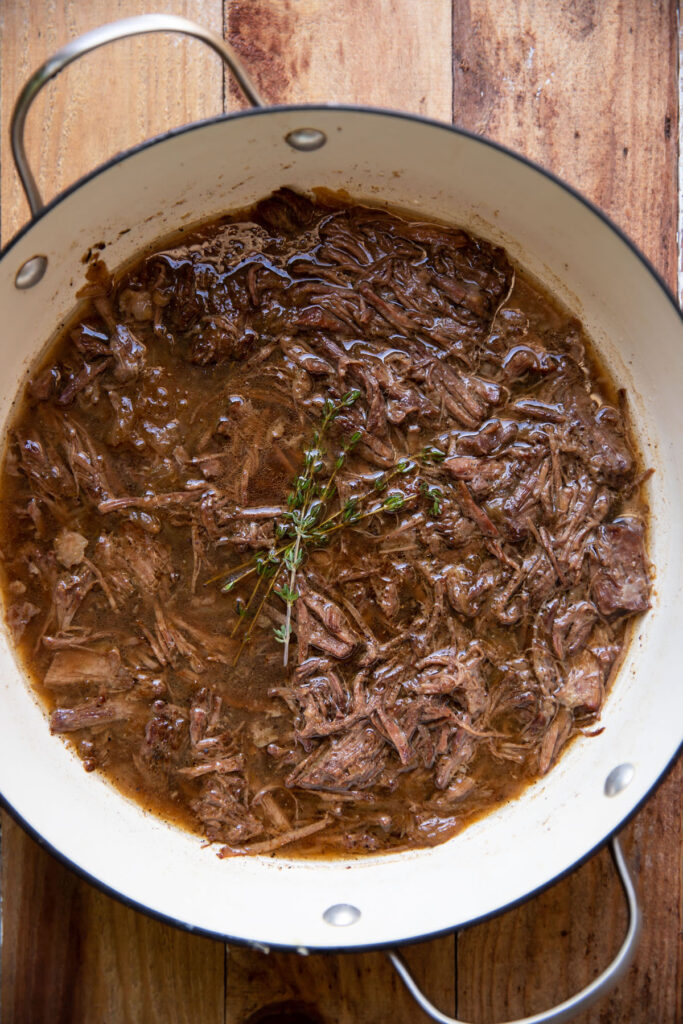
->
[453,0,678,286]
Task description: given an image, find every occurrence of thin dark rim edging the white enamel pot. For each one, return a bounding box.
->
[0,103,683,953]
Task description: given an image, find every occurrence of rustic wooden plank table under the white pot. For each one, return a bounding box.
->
[0,0,683,1024]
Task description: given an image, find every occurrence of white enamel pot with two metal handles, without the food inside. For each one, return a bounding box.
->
[0,15,683,1021]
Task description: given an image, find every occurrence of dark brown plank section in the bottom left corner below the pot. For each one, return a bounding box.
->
[0,815,224,1024]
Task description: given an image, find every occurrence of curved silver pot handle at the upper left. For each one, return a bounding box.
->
[10,14,265,217]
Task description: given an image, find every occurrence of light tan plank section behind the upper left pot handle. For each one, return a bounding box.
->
[0,0,223,241]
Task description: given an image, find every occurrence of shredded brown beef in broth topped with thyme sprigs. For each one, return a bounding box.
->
[1,190,649,855]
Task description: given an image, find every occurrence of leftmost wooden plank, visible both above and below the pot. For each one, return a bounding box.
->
[0,0,224,1024]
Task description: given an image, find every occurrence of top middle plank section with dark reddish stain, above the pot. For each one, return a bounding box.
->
[225,0,453,121]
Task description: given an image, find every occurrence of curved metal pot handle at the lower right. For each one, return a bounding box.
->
[386,837,641,1024]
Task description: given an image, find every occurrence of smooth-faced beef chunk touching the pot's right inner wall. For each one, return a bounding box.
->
[591,522,650,615]
